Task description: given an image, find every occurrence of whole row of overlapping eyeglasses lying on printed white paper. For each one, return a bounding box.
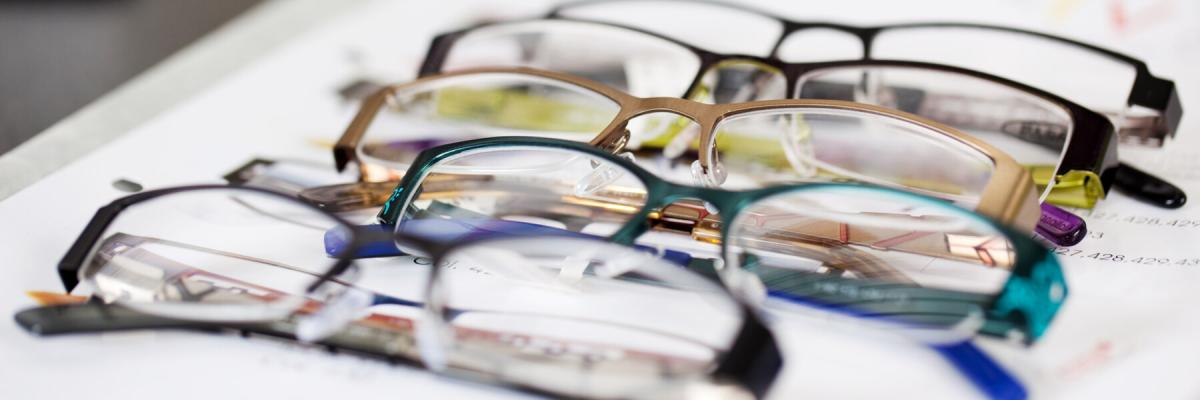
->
[17,0,1186,399]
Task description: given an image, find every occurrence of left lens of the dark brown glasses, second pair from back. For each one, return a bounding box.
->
[442,20,700,97]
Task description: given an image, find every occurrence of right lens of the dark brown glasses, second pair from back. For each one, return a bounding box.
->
[796,66,1074,200]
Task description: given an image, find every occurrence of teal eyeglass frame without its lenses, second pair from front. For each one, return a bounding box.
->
[377,135,1067,344]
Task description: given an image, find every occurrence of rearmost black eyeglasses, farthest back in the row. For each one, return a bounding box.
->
[548,0,1182,145]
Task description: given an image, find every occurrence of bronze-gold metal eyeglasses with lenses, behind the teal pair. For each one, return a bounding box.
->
[335,68,1038,237]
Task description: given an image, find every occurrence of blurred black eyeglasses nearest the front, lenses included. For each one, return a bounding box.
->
[49,186,780,398]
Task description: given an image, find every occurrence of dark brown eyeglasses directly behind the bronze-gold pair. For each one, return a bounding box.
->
[421,12,1186,208]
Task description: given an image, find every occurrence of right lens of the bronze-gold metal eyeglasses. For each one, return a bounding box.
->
[715,108,995,208]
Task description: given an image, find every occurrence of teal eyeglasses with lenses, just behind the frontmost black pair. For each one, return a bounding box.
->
[369,135,1067,341]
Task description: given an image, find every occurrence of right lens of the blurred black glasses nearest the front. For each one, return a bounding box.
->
[431,238,743,398]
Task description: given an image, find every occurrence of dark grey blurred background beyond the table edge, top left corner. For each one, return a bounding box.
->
[0,0,260,154]
